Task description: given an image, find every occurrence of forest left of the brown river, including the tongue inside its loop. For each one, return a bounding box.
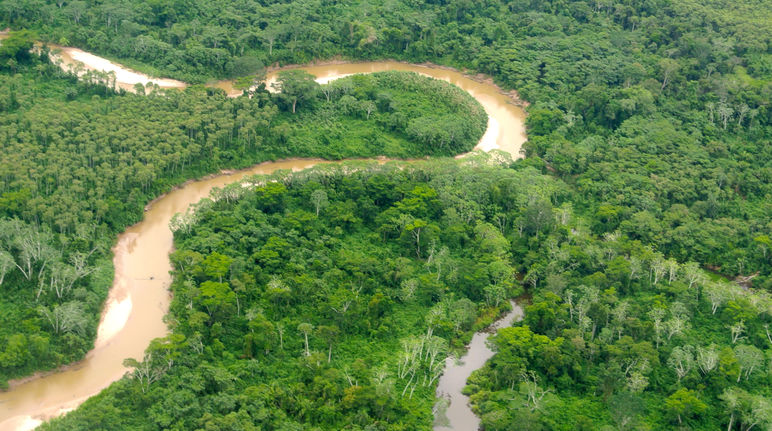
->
[0,35,487,383]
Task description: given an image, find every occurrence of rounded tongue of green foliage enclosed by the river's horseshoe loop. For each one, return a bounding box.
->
[288,71,488,158]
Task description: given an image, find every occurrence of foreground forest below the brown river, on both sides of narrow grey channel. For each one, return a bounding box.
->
[44,160,772,430]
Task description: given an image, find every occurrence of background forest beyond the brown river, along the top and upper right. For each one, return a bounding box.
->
[0,0,772,286]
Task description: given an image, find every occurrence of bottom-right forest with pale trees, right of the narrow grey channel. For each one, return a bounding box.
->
[465,208,772,431]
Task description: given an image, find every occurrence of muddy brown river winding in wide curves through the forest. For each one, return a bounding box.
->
[0,41,526,431]
